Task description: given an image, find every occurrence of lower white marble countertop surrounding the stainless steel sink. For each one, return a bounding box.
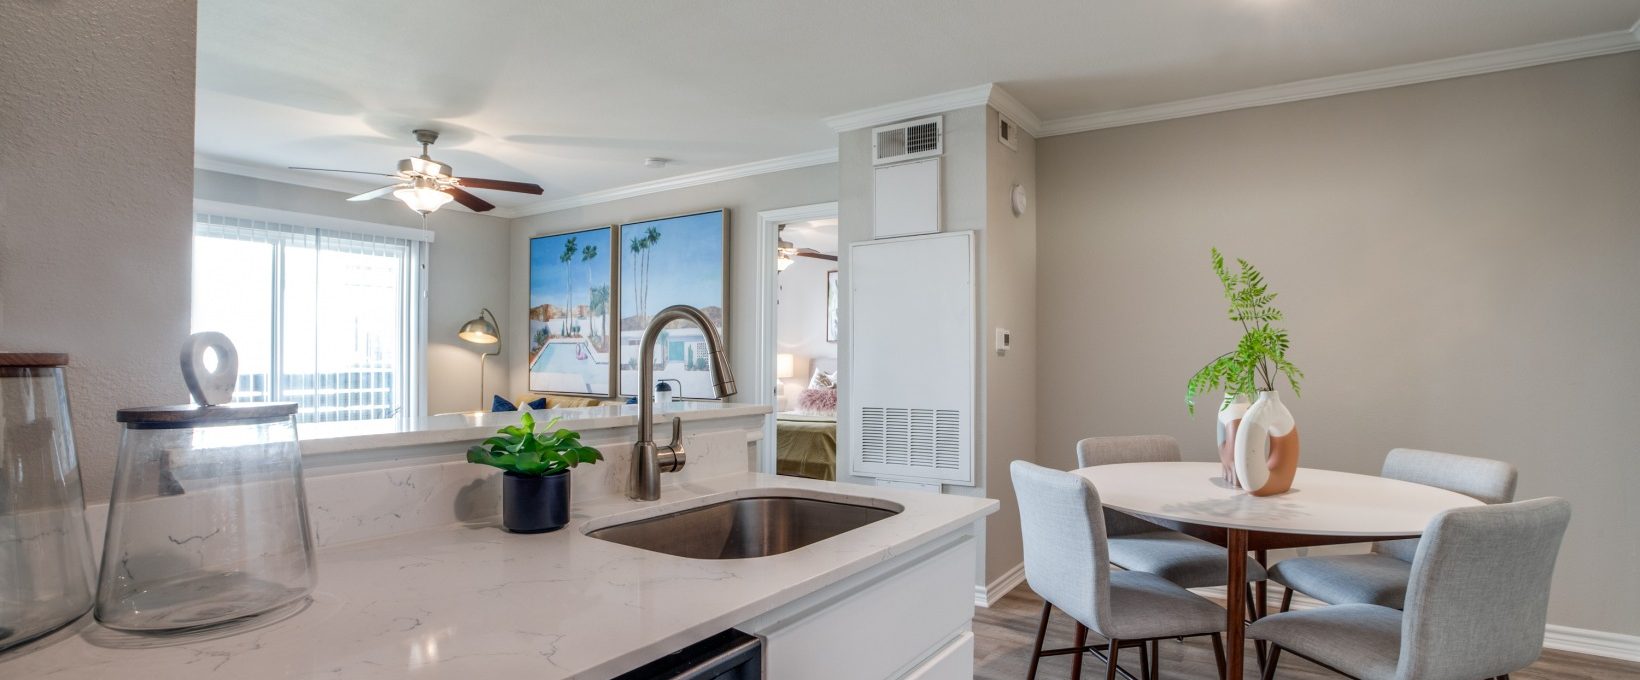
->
[0,475,997,680]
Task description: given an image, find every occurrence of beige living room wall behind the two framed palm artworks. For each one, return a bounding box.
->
[494,164,836,401]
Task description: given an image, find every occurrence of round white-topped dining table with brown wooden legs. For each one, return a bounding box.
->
[1074,462,1481,680]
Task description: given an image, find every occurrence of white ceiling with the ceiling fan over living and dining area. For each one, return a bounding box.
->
[195,0,1640,213]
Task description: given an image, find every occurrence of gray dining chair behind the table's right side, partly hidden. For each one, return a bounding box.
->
[1269,449,1517,611]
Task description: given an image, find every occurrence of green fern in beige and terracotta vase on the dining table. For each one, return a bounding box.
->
[1184,247,1304,496]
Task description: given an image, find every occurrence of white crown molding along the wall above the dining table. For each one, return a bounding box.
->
[1036,23,1640,136]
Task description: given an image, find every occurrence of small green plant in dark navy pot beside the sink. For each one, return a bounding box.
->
[467,411,604,534]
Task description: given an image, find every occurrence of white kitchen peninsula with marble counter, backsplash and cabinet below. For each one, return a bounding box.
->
[0,405,997,680]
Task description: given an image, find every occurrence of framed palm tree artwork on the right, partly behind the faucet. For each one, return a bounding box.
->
[615,210,728,398]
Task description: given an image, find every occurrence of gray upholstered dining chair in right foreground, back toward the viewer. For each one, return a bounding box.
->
[1246,498,1571,680]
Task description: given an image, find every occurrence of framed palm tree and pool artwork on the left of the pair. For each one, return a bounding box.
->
[528,226,617,397]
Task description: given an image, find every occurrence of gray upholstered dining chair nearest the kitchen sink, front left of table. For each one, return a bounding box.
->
[1009,460,1225,680]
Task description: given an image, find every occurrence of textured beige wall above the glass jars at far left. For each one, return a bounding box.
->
[0,0,195,501]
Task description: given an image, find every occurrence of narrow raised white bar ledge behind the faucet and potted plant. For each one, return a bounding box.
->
[297,401,769,456]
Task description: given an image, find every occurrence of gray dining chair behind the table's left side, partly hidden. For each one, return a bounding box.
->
[1076,434,1264,603]
